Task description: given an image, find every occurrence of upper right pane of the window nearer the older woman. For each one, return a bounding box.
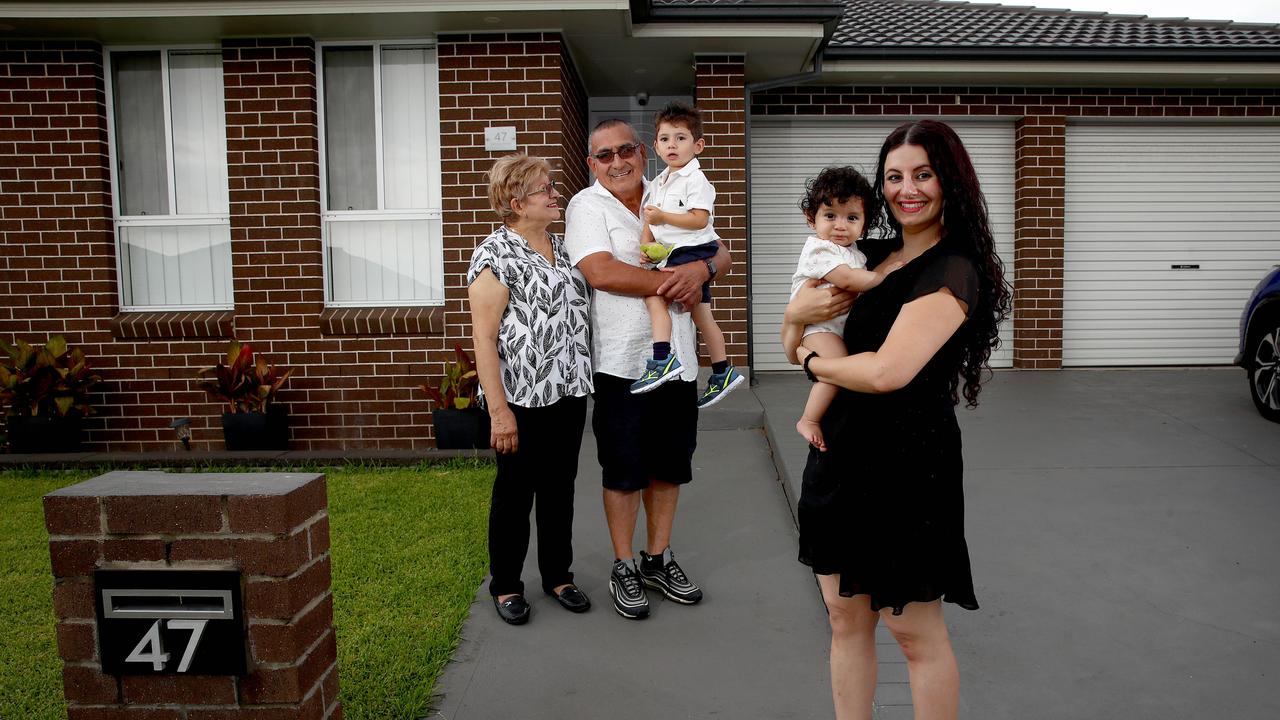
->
[381,47,435,209]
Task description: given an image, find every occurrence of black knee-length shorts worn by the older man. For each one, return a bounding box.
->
[591,373,698,491]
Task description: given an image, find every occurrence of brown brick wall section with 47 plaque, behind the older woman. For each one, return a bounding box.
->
[439,33,586,359]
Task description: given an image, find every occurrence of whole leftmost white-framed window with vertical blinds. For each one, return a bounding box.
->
[108,49,233,310]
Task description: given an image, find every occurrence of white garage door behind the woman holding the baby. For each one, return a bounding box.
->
[751,118,1014,370]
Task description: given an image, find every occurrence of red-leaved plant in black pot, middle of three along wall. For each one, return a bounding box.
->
[200,340,293,450]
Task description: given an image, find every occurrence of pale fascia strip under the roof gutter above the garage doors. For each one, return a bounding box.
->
[822,59,1280,81]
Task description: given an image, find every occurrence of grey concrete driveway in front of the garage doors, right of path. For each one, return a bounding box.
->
[756,368,1280,720]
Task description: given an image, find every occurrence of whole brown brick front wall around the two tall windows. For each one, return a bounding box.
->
[0,33,586,451]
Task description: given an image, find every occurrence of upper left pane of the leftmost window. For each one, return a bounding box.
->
[111,51,168,215]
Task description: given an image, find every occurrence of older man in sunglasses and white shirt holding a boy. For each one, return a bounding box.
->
[564,120,731,619]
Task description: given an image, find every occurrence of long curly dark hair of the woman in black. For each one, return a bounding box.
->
[876,120,1010,407]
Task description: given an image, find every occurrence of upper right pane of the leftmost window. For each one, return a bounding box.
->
[169,51,228,214]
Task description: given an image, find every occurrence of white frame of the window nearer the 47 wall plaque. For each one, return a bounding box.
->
[315,38,444,307]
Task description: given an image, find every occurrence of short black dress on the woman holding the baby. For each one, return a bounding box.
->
[797,241,980,615]
